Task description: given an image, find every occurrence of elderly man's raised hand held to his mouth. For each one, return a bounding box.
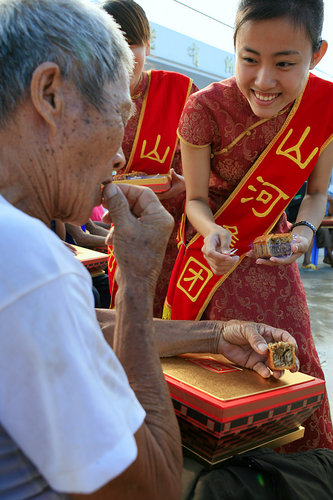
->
[103,184,174,286]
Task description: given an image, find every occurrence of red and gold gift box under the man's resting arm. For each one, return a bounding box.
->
[161,354,325,464]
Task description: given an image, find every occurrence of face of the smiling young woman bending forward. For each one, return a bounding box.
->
[236,18,315,118]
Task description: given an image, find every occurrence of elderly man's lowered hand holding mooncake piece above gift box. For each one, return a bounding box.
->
[218,320,299,378]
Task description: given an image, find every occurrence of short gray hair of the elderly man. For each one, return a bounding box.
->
[0,0,133,126]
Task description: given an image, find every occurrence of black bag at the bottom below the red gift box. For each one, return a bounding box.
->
[182,448,333,500]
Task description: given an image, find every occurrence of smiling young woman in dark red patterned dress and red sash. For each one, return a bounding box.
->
[164,0,333,451]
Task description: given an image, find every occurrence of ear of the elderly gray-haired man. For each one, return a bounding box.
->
[30,62,64,135]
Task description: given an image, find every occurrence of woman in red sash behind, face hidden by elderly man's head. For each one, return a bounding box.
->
[102,0,198,317]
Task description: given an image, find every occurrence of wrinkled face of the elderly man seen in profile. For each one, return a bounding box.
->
[58,67,133,224]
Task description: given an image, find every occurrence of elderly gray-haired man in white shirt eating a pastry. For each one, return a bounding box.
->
[0,0,304,500]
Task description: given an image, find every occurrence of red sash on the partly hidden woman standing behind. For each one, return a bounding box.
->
[108,71,192,307]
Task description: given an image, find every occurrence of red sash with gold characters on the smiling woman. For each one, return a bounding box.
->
[163,74,333,320]
